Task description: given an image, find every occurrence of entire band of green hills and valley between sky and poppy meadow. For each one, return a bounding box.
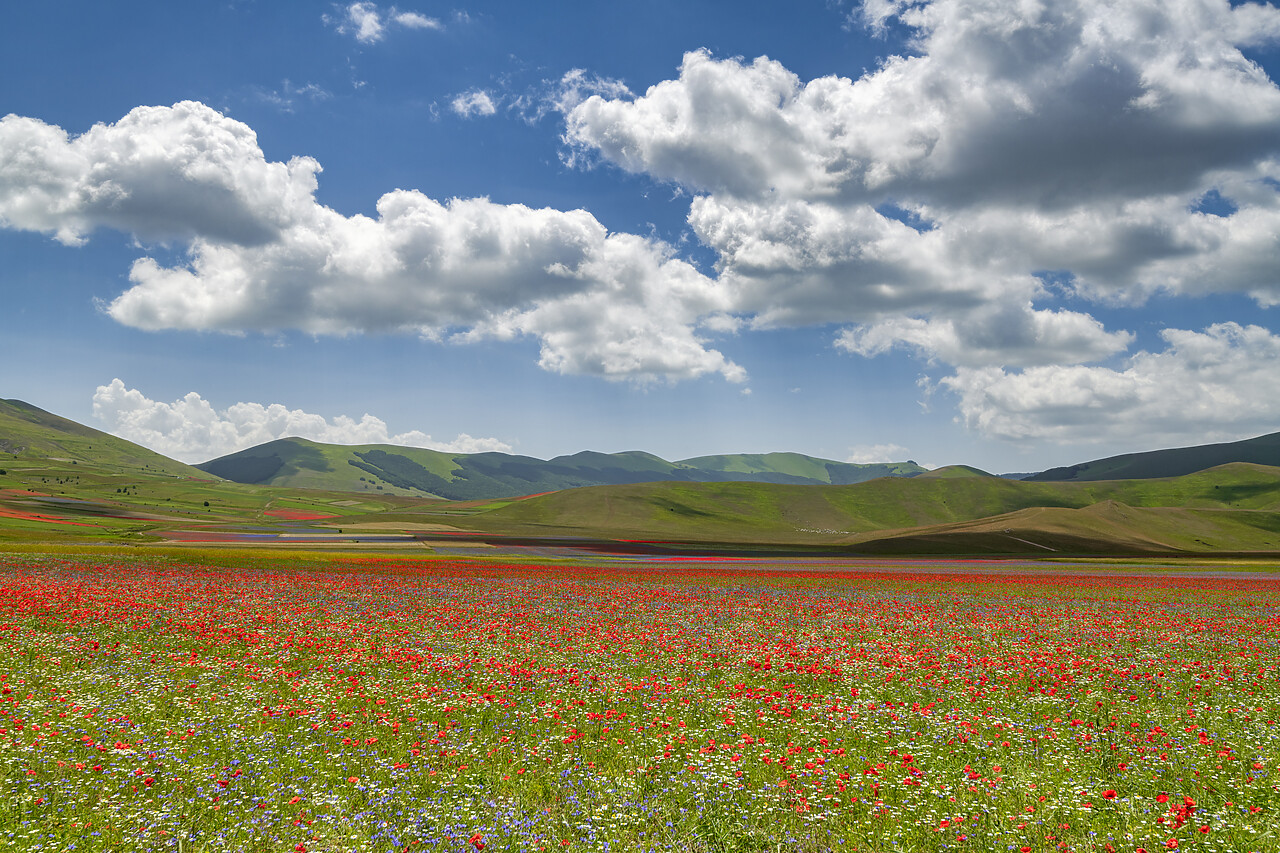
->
[0,400,1280,556]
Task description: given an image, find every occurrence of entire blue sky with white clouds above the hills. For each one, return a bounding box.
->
[0,0,1280,473]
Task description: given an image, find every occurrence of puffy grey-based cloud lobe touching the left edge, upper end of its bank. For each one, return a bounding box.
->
[0,101,320,246]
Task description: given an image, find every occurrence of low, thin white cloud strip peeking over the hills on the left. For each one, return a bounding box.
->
[93,379,511,462]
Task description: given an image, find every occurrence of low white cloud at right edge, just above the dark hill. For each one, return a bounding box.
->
[942,317,1280,446]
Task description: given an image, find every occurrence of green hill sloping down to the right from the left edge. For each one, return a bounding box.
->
[0,400,207,478]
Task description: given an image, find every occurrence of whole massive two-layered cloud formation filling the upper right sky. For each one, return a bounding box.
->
[564,0,1280,366]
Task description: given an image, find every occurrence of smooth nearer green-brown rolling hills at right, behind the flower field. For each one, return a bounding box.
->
[474,464,1280,552]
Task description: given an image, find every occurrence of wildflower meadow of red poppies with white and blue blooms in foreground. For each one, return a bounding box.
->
[0,556,1280,853]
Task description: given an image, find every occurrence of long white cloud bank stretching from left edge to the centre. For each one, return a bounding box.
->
[0,101,744,382]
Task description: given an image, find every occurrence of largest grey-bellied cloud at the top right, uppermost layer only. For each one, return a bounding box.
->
[566,7,1280,209]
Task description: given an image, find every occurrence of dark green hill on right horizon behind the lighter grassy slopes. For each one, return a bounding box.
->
[1025,433,1280,483]
